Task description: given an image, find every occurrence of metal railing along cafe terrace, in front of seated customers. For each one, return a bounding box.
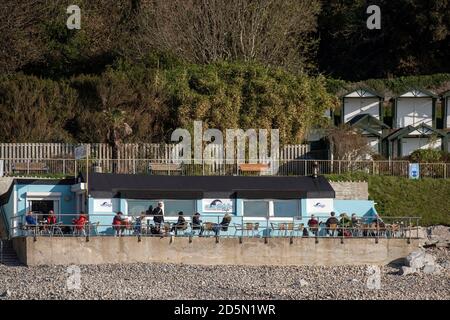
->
[11,214,420,239]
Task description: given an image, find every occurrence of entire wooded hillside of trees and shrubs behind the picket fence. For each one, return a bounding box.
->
[0,0,450,144]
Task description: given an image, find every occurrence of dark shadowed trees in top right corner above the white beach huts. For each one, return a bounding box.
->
[318,0,450,81]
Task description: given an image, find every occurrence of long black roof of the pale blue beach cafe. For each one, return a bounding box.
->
[88,173,335,199]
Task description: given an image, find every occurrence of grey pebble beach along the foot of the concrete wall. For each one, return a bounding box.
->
[0,248,450,300]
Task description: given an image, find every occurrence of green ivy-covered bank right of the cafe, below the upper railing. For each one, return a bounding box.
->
[328,174,450,226]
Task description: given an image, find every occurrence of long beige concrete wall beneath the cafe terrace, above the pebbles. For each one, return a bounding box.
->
[13,237,418,266]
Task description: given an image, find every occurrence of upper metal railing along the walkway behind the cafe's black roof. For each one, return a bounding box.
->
[3,159,450,179]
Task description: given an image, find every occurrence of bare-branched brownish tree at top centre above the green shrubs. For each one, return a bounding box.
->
[124,0,320,70]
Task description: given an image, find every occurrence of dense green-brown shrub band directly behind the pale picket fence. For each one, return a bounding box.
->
[0,61,337,143]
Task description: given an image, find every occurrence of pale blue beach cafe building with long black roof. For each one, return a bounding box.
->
[0,173,376,235]
